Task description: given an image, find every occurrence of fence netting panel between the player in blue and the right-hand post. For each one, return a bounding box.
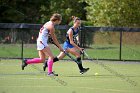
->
[82,30,120,59]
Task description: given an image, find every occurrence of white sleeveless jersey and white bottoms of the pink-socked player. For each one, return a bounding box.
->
[37,21,51,50]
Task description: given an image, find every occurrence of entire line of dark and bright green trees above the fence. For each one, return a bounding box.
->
[0,0,140,27]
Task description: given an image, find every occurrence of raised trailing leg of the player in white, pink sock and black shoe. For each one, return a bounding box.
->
[22,50,45,70]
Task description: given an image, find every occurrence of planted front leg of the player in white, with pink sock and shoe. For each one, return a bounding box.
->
[42,46,58,76]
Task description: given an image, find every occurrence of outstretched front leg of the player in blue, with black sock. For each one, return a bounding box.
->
[67,47,89,74]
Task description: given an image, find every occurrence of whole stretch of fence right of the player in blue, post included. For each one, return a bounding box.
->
[81,27,140,60]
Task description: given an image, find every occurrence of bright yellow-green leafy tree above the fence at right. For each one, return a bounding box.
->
[85,0,140,27]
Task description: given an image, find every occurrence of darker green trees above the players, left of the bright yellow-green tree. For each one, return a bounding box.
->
[0,0,86,24]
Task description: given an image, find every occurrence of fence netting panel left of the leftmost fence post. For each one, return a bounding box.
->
[0,29,22,58]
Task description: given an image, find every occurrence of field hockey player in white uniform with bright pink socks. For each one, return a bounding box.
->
[22,13,63,76]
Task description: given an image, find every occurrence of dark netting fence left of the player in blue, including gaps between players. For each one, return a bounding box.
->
[0,23,67,59]
